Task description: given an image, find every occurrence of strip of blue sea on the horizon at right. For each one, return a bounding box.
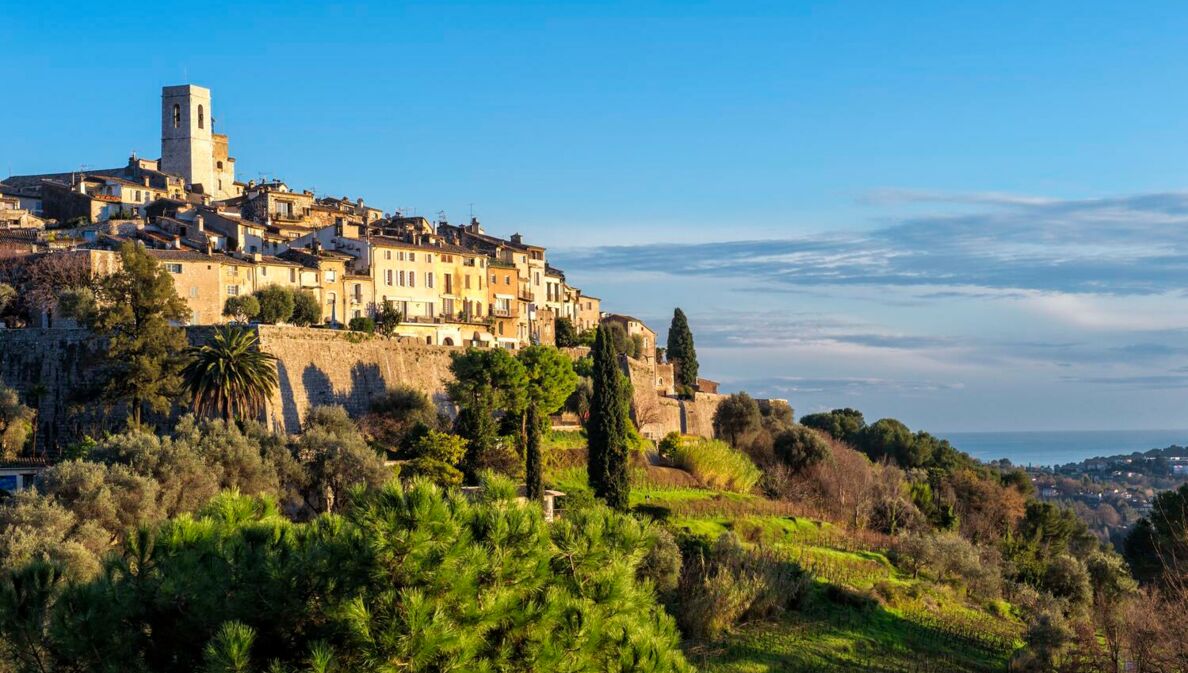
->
[936,429,1188,467]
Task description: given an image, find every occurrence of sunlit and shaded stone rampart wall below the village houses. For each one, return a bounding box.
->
[0,326,725,448]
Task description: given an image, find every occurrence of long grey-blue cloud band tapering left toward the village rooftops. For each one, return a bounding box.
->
[562,193,1188,295]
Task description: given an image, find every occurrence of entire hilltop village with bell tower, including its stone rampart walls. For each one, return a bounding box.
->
[0,84,722,454]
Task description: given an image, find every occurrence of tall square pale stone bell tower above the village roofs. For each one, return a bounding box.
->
[160,84,217,196]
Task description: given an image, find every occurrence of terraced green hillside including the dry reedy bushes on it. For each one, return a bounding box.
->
[549,430,1024,673]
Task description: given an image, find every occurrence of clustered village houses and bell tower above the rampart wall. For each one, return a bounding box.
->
[0,84,627,354]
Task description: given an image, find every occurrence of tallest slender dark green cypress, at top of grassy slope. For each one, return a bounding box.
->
[586,325,630,511]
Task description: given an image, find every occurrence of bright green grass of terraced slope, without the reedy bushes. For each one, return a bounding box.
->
[552,449,1023,673]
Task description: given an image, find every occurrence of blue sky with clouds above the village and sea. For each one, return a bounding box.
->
[0,0,1188,430]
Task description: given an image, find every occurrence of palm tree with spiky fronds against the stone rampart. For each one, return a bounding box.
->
[182,327,277,421]
